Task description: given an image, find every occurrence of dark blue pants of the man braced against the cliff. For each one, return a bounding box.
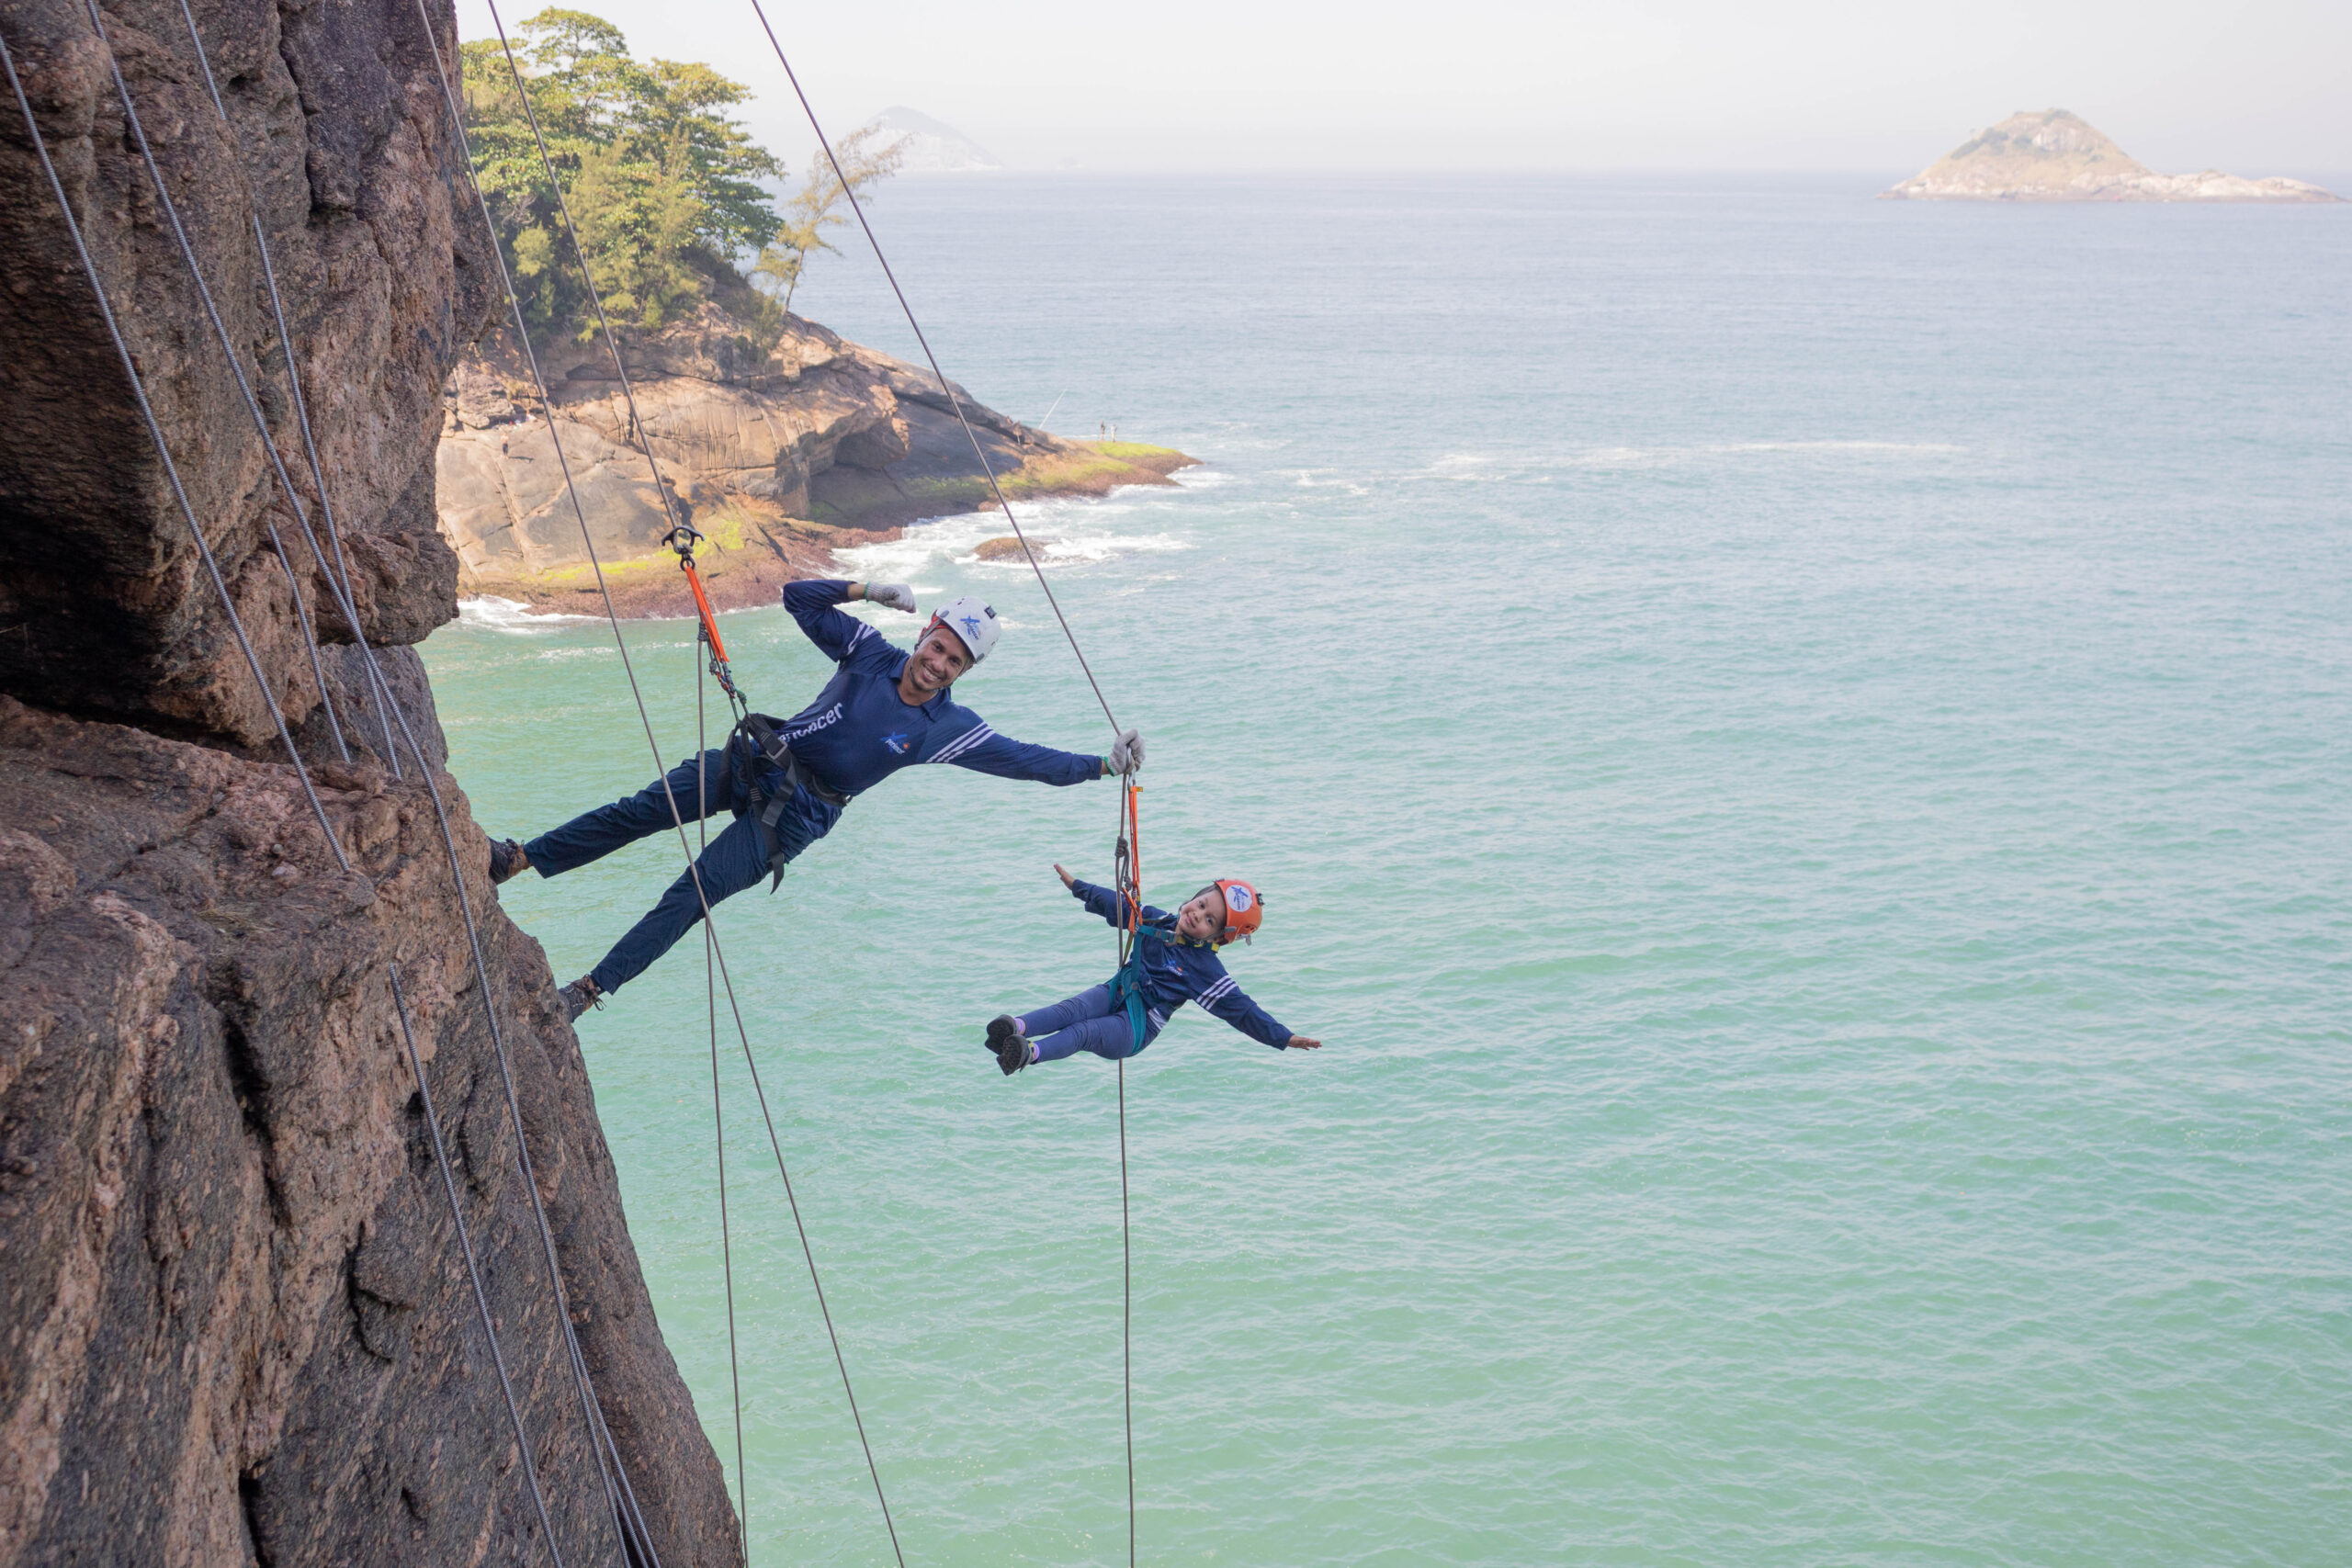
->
[522,750,775,995]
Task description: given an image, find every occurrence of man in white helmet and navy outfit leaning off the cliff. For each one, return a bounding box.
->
[489,581,1143,1021]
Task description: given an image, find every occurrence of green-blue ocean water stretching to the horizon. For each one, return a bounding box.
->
[425,176,2352,1568]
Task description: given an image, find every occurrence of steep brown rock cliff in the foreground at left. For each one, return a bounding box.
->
[0,0,736,1568]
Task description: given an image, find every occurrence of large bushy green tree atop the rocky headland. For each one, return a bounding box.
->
[461,9,781,333]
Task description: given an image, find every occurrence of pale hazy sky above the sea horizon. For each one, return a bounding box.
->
[458,0,2352,174]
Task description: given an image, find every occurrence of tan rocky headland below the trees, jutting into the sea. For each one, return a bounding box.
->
[437,301,1193,616]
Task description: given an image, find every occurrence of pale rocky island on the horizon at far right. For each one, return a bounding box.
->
[1879,108,2338,202]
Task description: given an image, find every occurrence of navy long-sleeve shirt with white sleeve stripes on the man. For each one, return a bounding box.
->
[776,581,1103,844]
